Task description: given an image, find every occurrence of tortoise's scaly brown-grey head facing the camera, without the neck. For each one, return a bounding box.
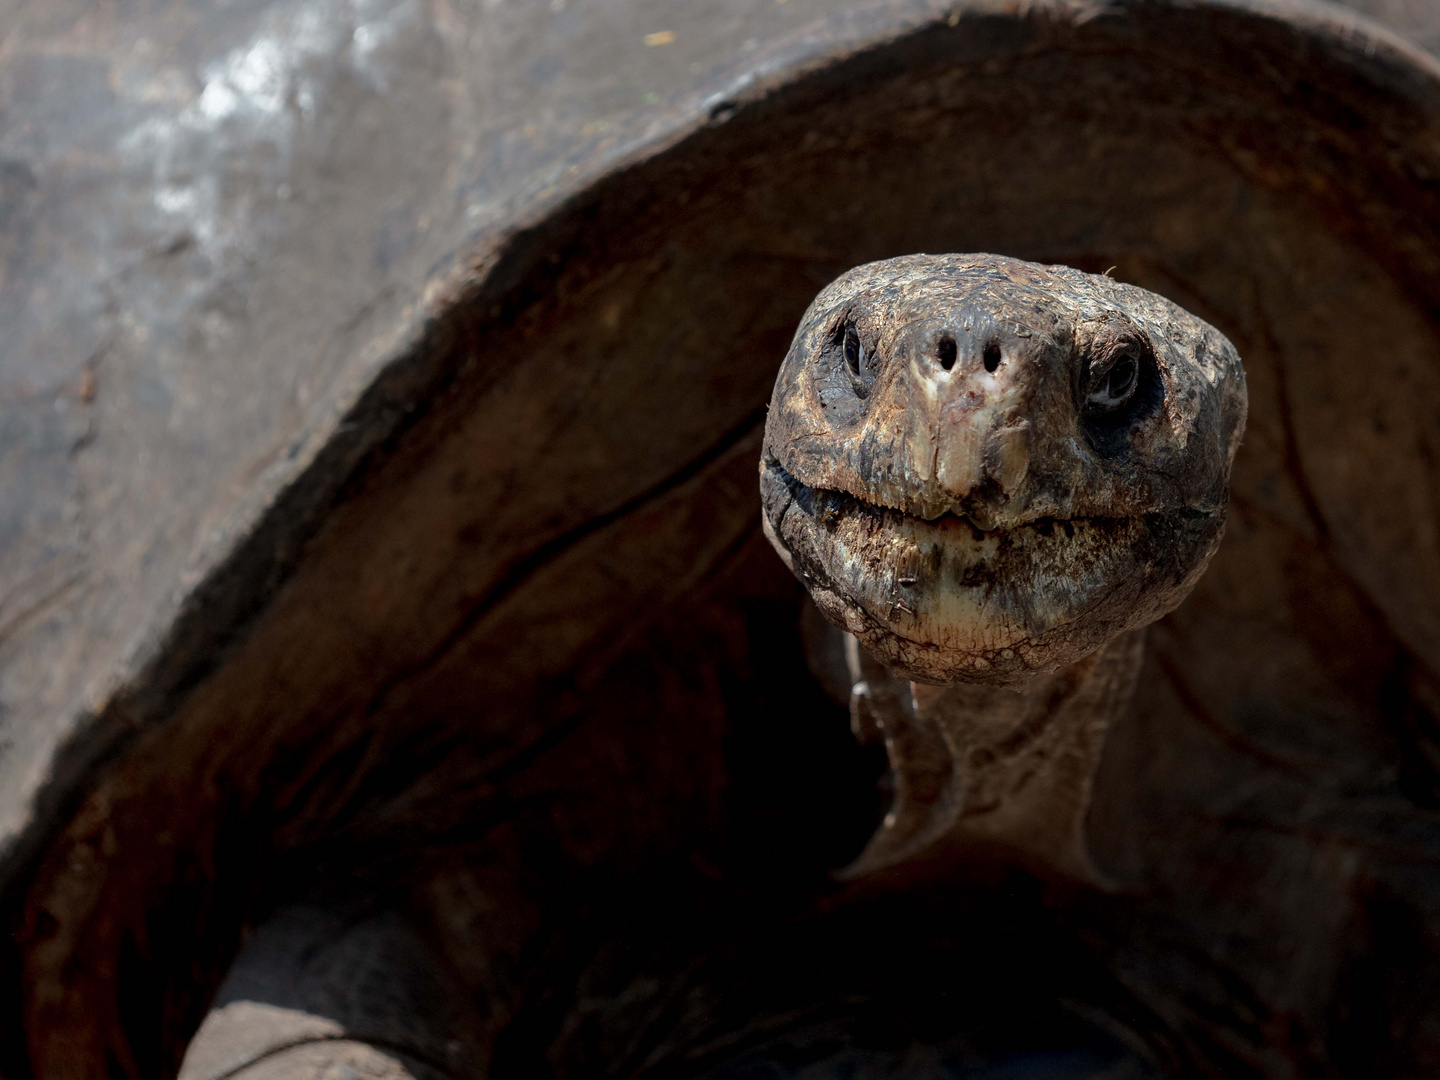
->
[760,255,1246,684]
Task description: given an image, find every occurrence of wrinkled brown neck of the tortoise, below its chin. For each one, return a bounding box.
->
[829,629,1145,888]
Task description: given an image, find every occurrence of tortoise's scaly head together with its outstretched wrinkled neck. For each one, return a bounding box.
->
[760,255,1246,881]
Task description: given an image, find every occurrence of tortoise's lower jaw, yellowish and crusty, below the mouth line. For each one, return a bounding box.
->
[762,469,1223,684]
